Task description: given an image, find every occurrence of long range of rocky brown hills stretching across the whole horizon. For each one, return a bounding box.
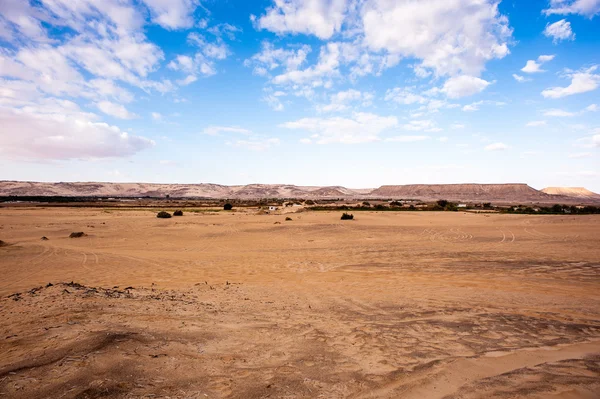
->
[0,181,600,204]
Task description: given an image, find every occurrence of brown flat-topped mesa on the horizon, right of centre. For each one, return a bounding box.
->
[371,183,552,202]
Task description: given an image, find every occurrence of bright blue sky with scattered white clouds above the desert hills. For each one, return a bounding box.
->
[0,0,600,192]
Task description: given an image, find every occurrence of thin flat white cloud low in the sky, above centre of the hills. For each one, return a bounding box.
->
[280,112,398,144]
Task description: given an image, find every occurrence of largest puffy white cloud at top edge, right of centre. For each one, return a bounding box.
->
[361,0,512,76]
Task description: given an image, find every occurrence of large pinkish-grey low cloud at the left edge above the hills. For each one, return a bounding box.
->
[0,99,154,160]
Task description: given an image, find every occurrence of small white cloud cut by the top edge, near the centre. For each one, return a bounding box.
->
[257,0,348,39]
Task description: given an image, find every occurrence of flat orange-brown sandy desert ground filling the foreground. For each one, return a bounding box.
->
[0,209,600,399]
